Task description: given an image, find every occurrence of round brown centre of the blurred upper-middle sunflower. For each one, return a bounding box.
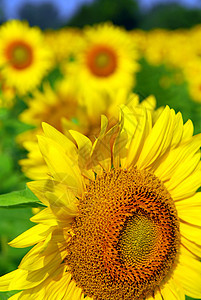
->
[87,45,117,77]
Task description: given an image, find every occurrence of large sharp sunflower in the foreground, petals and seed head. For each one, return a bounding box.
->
[0,97,201,300]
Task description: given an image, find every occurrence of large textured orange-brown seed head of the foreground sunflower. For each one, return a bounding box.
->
[65,168,180,300]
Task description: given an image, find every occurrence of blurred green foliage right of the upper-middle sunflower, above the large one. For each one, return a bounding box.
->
[134,59,201,133]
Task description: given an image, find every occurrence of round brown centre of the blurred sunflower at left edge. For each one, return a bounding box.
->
[5,41,33,70]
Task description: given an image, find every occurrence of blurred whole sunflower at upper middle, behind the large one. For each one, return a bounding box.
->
[66,23,139,92]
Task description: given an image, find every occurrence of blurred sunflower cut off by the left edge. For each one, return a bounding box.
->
[0,20,51,93]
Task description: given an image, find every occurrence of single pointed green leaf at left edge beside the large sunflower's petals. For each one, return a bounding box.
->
[0,188,44,208]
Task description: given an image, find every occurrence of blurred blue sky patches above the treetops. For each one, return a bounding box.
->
[2,0,201,19]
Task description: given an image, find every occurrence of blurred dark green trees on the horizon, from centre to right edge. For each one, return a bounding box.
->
[67,0,201,30]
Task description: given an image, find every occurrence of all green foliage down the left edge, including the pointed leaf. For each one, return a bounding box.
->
[0,98,36,282]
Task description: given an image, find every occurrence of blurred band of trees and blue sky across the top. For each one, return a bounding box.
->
[0,0,201,30]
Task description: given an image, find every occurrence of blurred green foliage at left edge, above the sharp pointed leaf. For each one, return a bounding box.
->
[0,103,31,194]
